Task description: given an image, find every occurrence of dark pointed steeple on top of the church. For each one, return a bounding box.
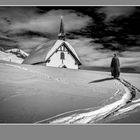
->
[58,16,65,40]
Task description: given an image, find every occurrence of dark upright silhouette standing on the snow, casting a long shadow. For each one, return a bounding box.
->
[110,54,120,78]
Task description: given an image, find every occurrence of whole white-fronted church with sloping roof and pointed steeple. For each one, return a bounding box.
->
[23,17,81,69]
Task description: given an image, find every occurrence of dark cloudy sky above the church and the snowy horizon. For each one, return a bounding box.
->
[0,6,140,67]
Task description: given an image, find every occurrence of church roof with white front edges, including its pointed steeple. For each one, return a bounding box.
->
[23,18,81,65]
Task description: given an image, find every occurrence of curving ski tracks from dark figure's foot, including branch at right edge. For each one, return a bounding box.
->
[39,79,140,124]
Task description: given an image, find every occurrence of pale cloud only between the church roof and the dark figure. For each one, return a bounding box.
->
[68,38,113,66]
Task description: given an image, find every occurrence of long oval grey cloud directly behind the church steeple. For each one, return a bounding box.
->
[10,10,91,34]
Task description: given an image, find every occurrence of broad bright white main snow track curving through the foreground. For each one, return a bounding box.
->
[40,79,131,124]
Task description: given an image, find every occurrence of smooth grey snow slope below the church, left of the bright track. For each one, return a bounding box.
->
[0,62,123,123]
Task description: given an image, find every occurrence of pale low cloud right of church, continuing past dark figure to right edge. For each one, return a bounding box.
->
[68,38,140,67]
